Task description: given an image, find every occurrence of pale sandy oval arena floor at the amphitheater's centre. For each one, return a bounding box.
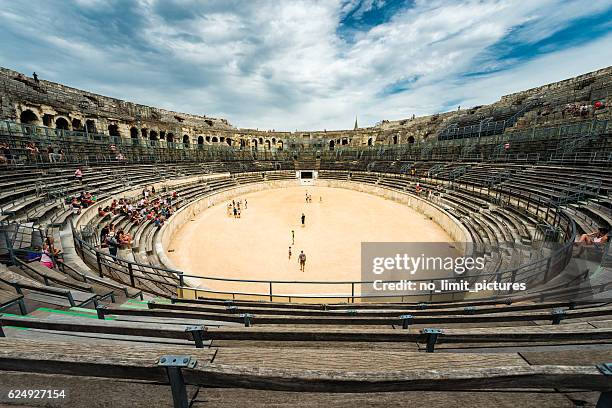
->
[167,186,451,293]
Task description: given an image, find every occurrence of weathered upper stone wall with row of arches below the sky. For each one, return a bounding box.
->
[0,67,612,150]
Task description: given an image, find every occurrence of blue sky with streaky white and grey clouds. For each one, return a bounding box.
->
[0,0,612,130]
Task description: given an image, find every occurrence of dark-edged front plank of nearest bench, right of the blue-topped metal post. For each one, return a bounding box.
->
[184,363,612,392]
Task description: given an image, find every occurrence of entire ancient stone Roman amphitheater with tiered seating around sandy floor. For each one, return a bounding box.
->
[0,67,612,407]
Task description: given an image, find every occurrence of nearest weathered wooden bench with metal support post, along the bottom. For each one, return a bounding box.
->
[0,339,612,407]
